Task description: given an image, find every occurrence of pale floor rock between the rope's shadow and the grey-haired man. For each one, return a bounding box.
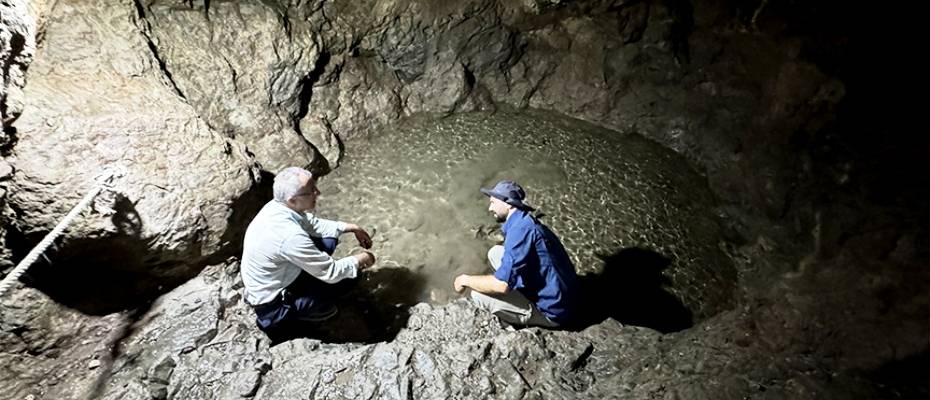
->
[98,264,271,399]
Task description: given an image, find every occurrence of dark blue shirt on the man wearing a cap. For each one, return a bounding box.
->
[494,210,579,324]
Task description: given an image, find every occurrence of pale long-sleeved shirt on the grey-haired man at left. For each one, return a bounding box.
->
[240,200,358,305]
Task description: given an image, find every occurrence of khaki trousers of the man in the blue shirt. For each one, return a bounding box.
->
[471,245,559,328]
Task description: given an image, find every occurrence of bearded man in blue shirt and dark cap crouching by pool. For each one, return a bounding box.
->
[453,181,579,328]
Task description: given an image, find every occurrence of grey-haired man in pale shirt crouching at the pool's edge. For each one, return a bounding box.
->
[241,167,375,335]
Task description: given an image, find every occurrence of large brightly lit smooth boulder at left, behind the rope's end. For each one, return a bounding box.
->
[7,2,255,296]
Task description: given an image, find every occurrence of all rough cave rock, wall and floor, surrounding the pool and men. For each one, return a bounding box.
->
[0,0,930,399]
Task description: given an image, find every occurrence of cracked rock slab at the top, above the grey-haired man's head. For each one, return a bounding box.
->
[141,2,328,172]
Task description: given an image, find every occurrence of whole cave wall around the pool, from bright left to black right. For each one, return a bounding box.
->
[0,0,928,398]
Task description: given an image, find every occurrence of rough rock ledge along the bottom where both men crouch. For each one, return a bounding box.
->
[5,233,926,399]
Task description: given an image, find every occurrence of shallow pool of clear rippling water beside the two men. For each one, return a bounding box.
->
[317,111,736,332]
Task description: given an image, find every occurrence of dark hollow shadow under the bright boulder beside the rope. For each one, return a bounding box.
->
[7,174,273,315]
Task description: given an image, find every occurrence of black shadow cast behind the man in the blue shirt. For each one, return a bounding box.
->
[574,247,693,333]
